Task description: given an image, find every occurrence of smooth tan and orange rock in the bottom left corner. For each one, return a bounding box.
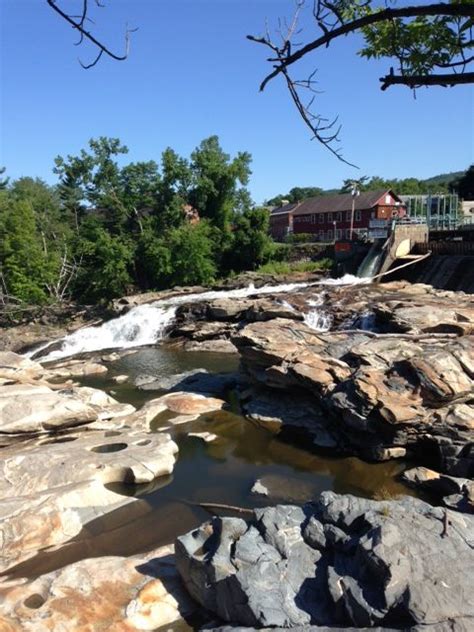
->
[2,546,196,632]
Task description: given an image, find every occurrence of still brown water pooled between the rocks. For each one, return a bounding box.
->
[9,345,413,578]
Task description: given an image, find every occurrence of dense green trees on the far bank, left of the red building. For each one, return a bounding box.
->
[0,136,326,303]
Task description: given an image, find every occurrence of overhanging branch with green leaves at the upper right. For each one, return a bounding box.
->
[248,0,474,166]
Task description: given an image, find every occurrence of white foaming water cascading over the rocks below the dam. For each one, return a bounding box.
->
[33,275,367,362]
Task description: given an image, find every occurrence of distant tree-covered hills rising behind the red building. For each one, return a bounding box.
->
[265,171,465,206]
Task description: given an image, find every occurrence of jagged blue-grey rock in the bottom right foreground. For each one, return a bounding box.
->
[176,492,474,629]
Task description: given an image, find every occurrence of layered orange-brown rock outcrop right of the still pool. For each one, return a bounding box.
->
[233,319,474,476]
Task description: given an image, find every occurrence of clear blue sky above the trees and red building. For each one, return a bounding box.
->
[0,0,474,202]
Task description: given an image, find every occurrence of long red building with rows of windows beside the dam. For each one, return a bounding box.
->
[270,190,406,241]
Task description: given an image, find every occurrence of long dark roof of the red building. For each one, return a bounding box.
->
[272,189,401,216]
